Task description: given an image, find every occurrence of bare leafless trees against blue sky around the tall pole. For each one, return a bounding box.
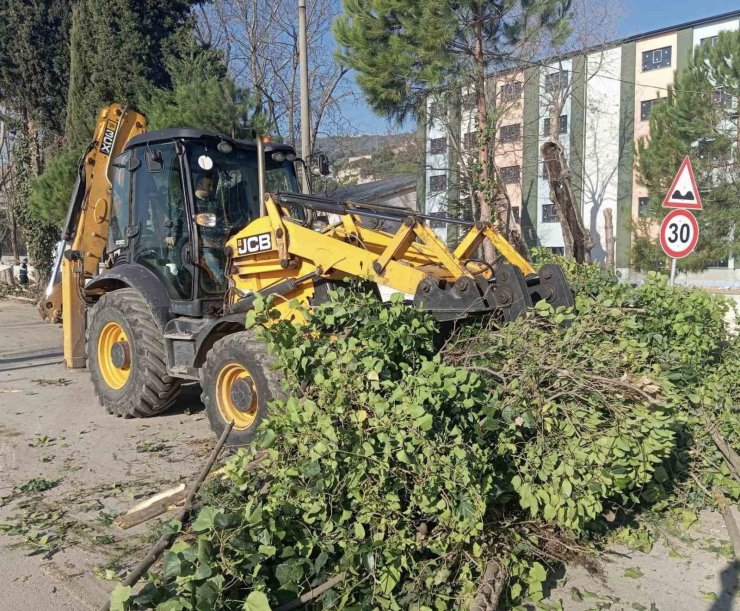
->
[197,0,354,152]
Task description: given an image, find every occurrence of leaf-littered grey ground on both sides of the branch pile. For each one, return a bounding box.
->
[0,301,740,611]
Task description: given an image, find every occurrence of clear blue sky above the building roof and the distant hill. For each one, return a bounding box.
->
[344,0,740,134]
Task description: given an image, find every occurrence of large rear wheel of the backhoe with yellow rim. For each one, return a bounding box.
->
[87,289,182,418]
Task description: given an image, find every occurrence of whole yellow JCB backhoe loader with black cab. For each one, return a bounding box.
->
[41,104,573,445]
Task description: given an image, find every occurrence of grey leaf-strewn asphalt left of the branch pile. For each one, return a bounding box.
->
[0,301,214,611]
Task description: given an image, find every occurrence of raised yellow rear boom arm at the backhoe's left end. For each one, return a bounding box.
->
[40,104,146,368]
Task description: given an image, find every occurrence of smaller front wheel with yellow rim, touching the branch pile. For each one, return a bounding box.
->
[200,331,283,447]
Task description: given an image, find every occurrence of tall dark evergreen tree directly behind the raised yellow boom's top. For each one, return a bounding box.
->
[66,0,194,146]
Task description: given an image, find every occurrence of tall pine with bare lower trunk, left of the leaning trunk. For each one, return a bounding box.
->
[334,0,570,260]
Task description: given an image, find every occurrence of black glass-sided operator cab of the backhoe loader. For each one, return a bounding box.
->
[107,129,301,316]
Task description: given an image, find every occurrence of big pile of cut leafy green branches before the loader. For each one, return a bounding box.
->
[117,267,740,611]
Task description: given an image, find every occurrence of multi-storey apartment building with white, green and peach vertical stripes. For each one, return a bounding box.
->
[420,11,740,285]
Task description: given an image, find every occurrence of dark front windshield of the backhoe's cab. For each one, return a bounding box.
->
[188,142,300,239]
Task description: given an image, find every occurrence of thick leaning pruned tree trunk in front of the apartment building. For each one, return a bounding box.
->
[540,141,594,263]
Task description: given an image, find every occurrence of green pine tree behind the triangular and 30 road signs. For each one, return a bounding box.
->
[633,32,740,270]
